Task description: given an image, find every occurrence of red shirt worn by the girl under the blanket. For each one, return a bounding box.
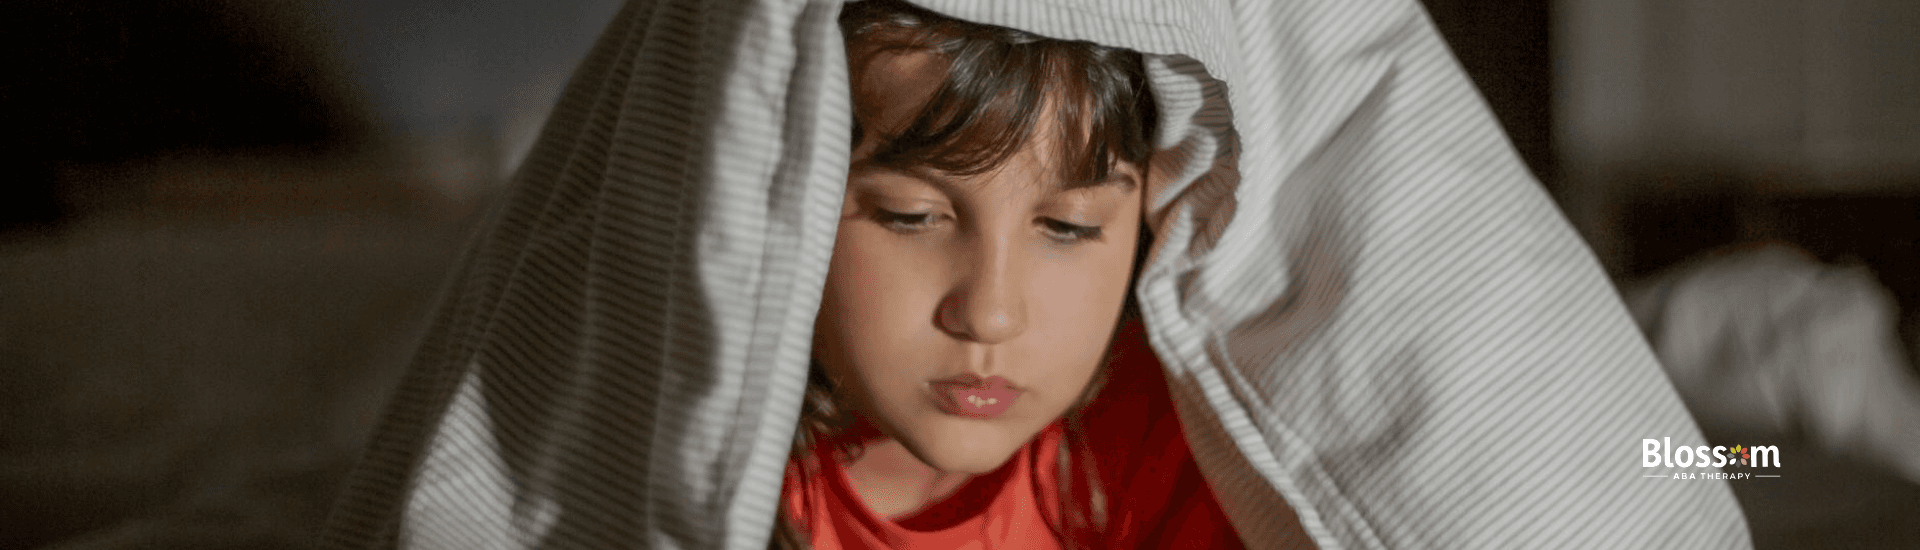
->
[783,325,1242,550]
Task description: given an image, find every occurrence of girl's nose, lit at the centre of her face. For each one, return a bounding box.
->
[939,237,1029,344]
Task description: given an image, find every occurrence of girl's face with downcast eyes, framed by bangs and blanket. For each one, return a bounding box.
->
[814,54,1144,473]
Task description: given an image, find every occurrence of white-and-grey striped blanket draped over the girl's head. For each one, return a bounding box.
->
[326,0,1751,548]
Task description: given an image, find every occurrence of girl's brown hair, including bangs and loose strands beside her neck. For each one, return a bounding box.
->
[772,0,1160,548]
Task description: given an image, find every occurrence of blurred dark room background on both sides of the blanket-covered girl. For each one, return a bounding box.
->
[0,0,1920,550]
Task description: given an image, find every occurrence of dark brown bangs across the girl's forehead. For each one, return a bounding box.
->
[843,2,1158,185]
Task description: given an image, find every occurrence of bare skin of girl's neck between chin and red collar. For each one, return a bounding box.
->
[847,438,972,517]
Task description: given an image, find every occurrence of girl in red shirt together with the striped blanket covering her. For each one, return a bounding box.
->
[328,0,1747,548]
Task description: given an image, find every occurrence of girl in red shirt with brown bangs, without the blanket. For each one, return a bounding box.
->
[780,2,1238,548]
